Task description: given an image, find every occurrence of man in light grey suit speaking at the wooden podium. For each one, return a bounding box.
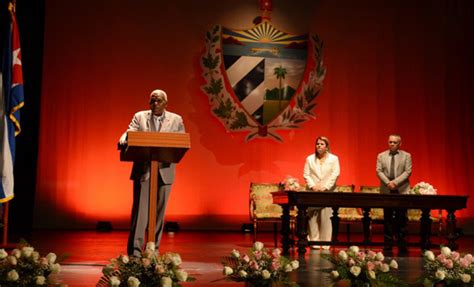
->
[119,90,184,256]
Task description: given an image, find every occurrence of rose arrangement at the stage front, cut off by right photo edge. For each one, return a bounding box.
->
[419,246,474,286]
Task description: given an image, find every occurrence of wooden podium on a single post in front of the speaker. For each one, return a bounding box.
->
[119,132,191,242]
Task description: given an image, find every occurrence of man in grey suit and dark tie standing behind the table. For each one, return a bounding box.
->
[377,134,412,256]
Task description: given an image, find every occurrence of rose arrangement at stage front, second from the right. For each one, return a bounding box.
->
[321,246,407,286]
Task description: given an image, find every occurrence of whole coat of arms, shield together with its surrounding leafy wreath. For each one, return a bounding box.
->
[201,3,326,141]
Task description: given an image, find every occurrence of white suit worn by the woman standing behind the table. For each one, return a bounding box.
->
[303,153,340,241]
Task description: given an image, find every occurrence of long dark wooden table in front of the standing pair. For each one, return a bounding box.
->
[272,191,469,255]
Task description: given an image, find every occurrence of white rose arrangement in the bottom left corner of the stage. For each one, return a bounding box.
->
[0,246,61,286]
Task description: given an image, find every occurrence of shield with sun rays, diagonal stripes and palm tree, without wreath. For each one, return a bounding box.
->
[222,22,308,125]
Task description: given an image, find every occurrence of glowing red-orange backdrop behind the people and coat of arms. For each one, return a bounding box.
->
[35,0,474,228]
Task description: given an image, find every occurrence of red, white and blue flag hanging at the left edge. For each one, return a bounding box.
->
[0,1,24,202]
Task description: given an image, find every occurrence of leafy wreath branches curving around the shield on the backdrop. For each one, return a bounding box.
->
[201,25,326,142]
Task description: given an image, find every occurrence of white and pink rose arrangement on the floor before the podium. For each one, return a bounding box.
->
[97,242,194,287]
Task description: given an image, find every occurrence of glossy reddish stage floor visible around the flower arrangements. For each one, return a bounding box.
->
[8,231,474,287]
